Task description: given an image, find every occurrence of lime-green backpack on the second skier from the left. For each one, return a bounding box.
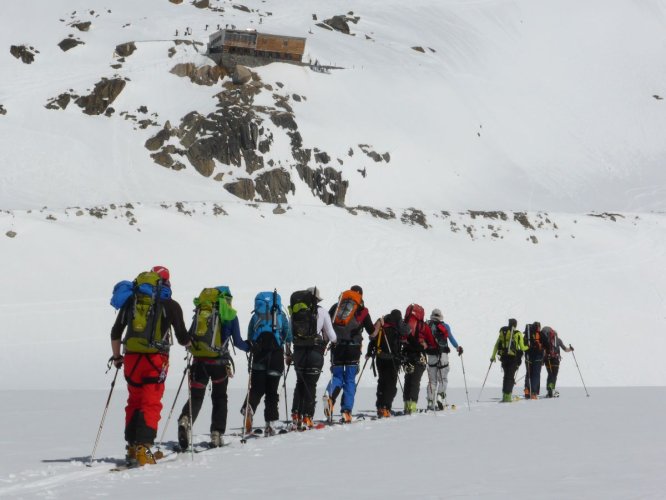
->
[189,287,236,358]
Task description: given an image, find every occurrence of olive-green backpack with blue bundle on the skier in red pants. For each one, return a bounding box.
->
[122,271,171,353]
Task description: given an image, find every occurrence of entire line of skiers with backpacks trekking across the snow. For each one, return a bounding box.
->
[109,266,573,465]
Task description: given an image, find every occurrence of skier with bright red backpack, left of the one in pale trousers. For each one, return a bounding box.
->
[402,304,434,414]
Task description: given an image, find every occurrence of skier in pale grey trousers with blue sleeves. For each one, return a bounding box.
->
[426,309,463,410]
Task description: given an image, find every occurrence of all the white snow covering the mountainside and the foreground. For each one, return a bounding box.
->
[0,0,666,499]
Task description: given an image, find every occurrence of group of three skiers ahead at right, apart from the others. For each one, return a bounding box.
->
[488,318,574,402]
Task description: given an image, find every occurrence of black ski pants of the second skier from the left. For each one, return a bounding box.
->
[178,358,229,434]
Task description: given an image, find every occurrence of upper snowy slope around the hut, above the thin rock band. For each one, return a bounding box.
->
[0,0,666,212]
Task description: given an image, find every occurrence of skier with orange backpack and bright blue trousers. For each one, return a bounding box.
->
[324,285,379,423]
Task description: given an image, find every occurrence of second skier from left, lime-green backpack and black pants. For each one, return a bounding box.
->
[178,286,249,450]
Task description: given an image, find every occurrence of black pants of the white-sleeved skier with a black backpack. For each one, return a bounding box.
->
[291,346,324,417]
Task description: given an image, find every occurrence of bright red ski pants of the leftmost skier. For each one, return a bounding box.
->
[124,353,169,444]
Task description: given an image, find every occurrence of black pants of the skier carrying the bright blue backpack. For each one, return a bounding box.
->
[250,349,284,422]
